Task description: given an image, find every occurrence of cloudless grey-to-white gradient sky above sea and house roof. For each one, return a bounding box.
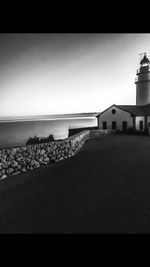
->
[0,34,150,116]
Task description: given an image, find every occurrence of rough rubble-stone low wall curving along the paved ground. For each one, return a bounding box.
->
[0,131,90,179]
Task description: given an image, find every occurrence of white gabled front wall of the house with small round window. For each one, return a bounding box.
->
[98,106,133,130]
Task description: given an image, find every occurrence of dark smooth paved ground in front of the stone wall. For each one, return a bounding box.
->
[0,136,150,233]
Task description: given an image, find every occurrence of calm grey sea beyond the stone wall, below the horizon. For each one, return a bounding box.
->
[0,116,97,148]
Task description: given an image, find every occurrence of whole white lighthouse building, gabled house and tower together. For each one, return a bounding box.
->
[96,53,150,131]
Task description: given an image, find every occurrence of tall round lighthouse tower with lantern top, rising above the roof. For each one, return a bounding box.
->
[135,53,150,106]
